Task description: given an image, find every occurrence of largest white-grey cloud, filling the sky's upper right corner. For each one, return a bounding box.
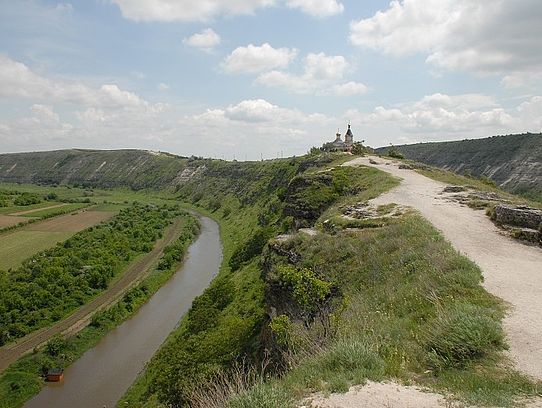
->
[350,0,542,83]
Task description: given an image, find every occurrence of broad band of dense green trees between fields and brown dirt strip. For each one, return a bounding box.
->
[0,204,183,344]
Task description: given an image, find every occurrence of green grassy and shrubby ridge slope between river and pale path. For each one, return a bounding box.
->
[120,156,537,407]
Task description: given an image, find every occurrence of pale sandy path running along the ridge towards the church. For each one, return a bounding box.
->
[344,157,542,379]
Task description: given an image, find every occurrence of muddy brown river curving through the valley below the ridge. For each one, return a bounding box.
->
[25,217,222,408]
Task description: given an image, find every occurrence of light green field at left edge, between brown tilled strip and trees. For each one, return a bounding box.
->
[0,230,75,270]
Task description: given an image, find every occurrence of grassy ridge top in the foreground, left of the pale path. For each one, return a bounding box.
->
[248,214,540,406]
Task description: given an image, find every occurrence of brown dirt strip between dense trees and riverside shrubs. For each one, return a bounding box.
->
[0,220,182,373]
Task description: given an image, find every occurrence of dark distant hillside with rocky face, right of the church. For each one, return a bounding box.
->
[376,133,542,193]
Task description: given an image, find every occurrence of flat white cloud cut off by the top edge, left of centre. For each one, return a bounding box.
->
[110,0,344,21]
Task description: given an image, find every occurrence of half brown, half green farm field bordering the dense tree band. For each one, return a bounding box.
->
[0,211,114,270]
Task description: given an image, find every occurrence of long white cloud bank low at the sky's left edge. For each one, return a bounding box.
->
[0,55,148,107]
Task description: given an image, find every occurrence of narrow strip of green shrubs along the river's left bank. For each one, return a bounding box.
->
[0,212,199,408]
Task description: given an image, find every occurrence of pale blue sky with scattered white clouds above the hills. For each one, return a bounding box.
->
[0,0,542,160]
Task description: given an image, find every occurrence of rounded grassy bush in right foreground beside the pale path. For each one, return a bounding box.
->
[425,304,506,369]
